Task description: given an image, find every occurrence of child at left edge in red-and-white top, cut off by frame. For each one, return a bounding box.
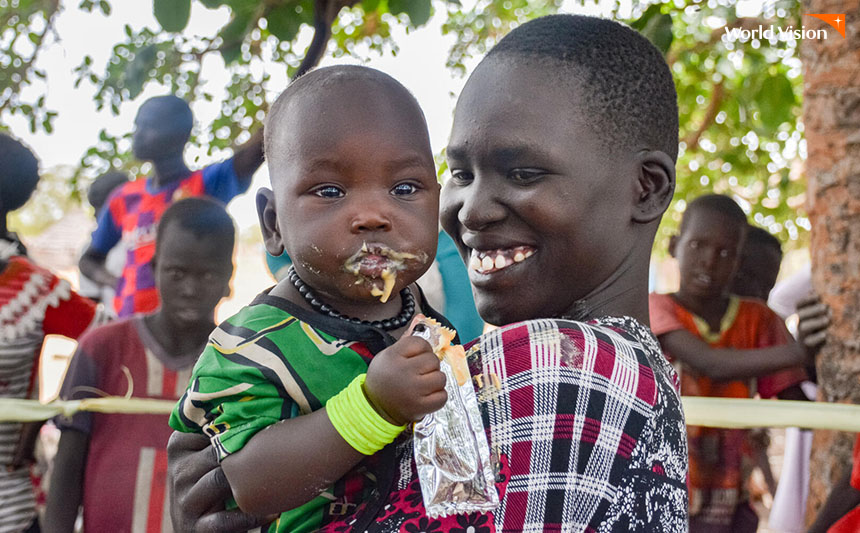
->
[0,134,100,532]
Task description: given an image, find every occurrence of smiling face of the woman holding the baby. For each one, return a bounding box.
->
[441,59,634,325]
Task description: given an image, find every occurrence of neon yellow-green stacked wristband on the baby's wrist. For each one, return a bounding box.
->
[325,374,406,455]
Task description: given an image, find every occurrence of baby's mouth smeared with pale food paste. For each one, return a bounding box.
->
[344,242,426,303]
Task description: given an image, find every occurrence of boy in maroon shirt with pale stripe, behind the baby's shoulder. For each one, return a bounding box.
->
[46,198,235,533]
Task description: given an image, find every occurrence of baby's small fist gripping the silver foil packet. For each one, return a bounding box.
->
[364,336,448,425]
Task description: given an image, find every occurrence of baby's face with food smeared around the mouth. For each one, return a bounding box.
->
[267,81,439,312]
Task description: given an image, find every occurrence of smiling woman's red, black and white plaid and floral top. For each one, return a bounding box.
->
[356,318,687,533]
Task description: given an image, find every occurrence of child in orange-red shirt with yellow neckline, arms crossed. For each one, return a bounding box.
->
[650,195,816,533]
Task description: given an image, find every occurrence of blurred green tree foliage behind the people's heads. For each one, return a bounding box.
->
[0,0,809,254]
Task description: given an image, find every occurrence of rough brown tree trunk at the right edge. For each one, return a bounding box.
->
[801,0,860,522]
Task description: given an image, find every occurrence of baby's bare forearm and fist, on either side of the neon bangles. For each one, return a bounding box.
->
[222,337,447,515]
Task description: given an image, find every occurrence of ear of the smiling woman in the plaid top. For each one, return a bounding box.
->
[633,150,675,224]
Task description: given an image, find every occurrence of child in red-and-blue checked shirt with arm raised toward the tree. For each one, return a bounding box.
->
[79,95,263,317]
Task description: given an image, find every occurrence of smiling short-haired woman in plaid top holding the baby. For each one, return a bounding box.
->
[168,15,687,532]
